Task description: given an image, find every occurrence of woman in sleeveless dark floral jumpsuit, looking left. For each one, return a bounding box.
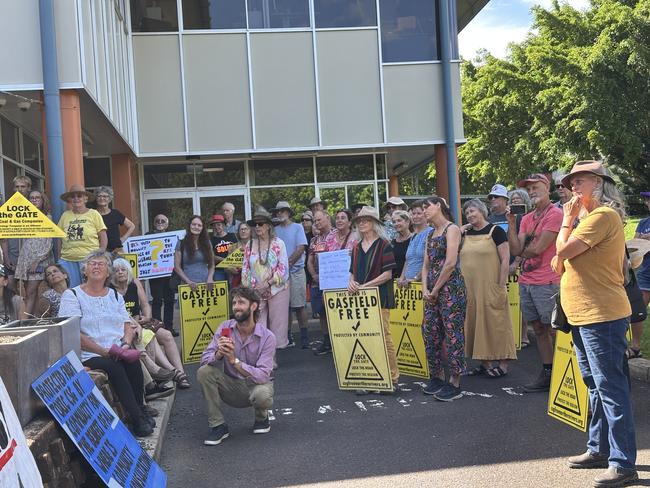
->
[422,196,467,402]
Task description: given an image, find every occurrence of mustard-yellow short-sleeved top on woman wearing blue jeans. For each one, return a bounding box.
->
[560,207,632,325]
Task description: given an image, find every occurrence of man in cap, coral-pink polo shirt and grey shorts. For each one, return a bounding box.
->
[507,173,563,392]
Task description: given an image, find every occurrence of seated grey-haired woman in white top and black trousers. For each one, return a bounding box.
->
[59,250,155,437]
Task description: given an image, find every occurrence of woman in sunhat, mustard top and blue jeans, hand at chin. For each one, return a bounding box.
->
[551,161,638,486]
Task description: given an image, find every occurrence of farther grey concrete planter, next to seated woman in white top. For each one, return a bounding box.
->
[0,317,81,366]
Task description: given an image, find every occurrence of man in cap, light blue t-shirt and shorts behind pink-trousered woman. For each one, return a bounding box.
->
[272,201,309,349]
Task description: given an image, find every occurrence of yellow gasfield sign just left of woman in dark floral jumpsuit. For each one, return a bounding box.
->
[390,282,429,379]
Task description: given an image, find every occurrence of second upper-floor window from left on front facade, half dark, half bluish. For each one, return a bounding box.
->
[183,0,246,29]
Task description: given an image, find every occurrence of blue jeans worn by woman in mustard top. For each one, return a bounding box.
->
[571,318,636,471]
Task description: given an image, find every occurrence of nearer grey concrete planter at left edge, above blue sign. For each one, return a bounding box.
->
[0,329,48,426]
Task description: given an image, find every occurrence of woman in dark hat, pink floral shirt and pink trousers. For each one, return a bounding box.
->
[241,210,290,349]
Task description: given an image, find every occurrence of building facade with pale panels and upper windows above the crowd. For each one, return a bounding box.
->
[0,0,486,231]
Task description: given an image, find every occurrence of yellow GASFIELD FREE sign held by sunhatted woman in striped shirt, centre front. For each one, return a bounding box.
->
[323,288,393,391]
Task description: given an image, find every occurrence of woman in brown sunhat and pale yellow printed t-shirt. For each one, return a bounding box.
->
[58,185,108,288]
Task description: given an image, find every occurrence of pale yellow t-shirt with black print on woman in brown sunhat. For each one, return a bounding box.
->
[58,208,106,261]
